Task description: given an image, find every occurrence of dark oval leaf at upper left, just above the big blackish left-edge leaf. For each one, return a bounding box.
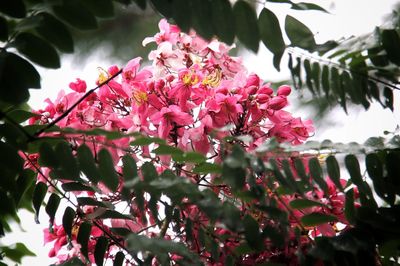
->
[12,32,60,68]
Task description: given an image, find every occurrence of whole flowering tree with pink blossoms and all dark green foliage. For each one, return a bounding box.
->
[0,0,400,265]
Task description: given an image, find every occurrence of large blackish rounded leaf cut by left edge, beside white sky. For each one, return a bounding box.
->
[0,51,40,104]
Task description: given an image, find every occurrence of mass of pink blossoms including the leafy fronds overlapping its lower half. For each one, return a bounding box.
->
[23,20,360,265]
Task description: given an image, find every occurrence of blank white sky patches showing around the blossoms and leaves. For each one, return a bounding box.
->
[1,0,400,265]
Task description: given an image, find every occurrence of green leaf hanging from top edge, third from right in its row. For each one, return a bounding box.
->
[233,0,260,52]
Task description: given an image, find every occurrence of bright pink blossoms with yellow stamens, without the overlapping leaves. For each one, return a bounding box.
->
[30,20,324,265]
